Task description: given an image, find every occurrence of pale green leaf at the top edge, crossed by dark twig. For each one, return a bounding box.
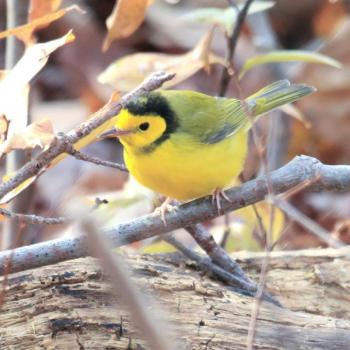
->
[180,1,275,35]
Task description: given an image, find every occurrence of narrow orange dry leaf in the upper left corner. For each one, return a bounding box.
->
[0,5,81,45]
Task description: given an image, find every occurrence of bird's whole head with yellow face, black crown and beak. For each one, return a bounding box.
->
[101,92,177,151]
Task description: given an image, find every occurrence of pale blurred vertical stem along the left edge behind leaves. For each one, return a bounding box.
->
[2,0,29,249]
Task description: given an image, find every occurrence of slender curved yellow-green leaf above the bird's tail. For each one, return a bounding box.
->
[239,50,342,79]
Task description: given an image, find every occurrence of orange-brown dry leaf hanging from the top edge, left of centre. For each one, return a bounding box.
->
[102,0,152,51]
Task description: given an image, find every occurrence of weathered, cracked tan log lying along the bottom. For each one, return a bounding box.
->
[0,248,350,350]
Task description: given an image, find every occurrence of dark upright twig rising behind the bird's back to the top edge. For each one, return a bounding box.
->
[219,0,254,96]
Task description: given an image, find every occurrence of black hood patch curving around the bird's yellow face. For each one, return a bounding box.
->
[125,92,179,153]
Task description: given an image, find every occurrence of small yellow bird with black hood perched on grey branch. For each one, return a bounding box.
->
[100,79,315,222]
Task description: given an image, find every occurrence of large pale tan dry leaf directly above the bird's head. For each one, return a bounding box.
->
[98,29,225,92]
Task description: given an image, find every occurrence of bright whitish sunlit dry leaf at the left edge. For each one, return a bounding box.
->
[0,31,74,136]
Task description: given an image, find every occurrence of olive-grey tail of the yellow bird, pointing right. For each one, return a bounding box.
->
[246,79,316,116]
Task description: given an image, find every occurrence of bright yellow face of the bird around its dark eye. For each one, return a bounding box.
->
[115,109,166,148]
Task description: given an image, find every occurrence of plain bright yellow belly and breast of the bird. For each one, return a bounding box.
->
[124,129,247,201]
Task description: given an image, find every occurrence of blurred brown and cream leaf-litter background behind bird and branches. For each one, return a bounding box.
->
[0,0,350,252]
